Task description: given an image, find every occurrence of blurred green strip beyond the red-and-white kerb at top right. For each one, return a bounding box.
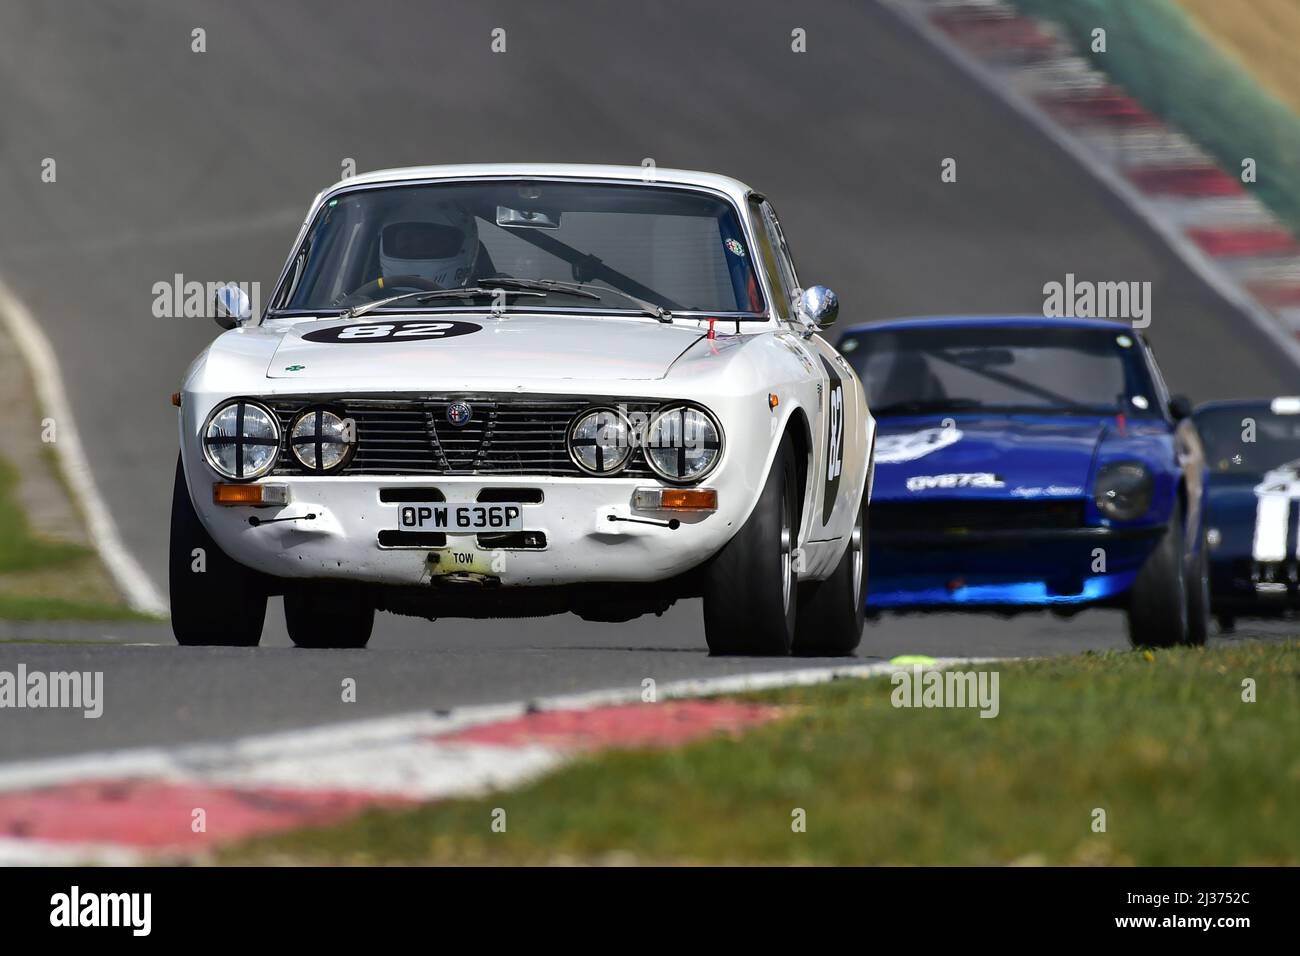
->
[1011,0,1300,234]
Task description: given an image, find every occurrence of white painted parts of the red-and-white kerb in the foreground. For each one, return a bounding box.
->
[0,658,1015,866]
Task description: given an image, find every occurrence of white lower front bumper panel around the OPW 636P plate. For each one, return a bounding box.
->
[190,476,748,587]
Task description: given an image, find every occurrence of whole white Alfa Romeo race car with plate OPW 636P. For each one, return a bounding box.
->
[170,165,875,654]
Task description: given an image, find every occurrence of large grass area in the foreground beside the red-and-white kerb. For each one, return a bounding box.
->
[218,643,1300,865]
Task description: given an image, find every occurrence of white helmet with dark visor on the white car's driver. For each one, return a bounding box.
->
[380,203,478,289]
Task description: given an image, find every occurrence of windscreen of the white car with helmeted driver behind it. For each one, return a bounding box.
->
[273,179,764,313]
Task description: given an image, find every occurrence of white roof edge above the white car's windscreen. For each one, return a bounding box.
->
[312,163,753,204]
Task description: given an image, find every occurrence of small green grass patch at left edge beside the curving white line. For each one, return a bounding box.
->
[0,460,151,620]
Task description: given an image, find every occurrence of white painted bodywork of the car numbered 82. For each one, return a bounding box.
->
[179,165,875,598]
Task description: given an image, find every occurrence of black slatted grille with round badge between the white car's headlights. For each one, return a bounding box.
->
[268,395,663,477]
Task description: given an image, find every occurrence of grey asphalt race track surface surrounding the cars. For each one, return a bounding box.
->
[0,0,1296,758]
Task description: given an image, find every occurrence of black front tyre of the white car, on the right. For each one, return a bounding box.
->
[705,436,800,657]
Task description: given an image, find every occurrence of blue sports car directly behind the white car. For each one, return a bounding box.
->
[839,317,1209,646]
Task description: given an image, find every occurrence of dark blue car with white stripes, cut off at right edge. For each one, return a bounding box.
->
[1192,395,1300,631]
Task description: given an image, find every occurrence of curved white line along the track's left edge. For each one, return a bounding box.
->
[0,281,168,615]
